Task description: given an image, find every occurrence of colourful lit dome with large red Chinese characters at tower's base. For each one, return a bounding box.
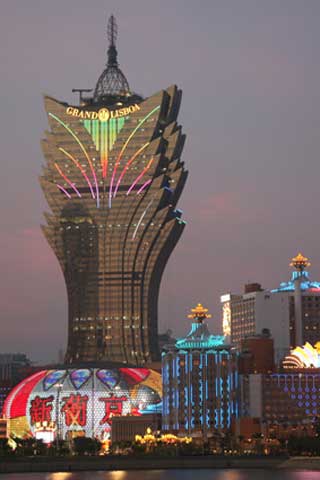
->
[3,368,162,440]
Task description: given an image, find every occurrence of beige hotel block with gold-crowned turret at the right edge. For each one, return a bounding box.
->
[221,253,320,363]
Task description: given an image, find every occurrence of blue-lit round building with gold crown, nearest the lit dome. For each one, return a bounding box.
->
[162,304,238,438]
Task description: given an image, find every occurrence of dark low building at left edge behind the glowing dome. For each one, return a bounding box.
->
[0,353,32,417]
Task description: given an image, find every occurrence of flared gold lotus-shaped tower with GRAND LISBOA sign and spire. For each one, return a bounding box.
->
[40,16,187,365]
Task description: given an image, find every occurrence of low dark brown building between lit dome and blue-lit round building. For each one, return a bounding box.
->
[111,413,161,443]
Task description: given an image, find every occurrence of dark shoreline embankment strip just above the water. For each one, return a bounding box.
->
[0,455,320,474]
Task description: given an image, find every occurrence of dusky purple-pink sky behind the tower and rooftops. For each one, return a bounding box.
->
[0,0,320,361]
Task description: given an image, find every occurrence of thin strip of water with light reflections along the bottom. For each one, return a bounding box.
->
[4,469,320,480]
